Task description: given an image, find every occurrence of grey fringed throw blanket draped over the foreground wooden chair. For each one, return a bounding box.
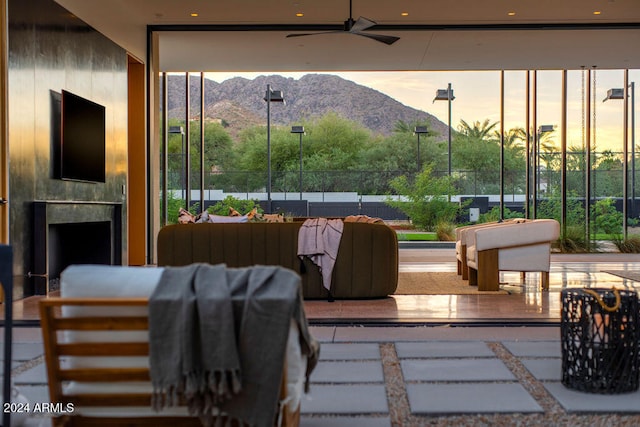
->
[149,264,318,426]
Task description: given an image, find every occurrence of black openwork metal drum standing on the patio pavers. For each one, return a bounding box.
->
[560,288,640,394]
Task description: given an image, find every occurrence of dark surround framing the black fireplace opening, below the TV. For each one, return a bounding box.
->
[31,200,122,295]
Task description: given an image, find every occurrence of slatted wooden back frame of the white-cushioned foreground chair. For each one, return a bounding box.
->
[40,298,300,427]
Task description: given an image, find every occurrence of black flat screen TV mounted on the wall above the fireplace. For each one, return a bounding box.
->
[60,90,105,182]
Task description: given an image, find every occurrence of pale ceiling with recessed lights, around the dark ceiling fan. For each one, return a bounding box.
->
[56,0,640,71]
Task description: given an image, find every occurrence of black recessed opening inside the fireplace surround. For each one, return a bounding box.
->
[48,221,113,291]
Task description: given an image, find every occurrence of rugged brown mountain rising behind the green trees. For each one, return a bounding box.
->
[168,74,447,136]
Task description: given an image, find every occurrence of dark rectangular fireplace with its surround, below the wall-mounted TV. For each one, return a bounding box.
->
[31,201,122,295]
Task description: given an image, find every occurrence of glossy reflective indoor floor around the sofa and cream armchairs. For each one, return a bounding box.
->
[8,249,640,325]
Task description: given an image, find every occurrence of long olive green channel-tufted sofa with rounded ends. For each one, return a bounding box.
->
[158,222,398,299]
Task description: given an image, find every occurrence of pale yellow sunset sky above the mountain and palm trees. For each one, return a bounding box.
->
[206,70,640,151]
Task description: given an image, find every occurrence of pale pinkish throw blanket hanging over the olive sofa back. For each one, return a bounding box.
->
[298,218,344,292]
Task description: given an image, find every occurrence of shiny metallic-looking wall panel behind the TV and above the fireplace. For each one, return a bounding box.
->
[8,0,127,296]
